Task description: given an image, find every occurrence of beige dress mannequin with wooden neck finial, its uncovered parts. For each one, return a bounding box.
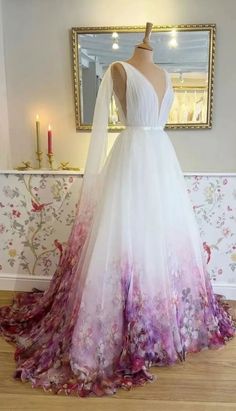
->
[111,22,166,114]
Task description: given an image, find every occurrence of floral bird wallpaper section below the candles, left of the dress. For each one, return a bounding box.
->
[0,174,82,276]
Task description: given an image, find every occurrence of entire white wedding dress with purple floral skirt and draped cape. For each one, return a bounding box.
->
[0,61,236,396]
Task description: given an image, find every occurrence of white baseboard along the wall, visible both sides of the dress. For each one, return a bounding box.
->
[0,273,236,301]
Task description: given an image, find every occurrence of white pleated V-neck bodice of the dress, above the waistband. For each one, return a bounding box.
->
[111,61,174,127]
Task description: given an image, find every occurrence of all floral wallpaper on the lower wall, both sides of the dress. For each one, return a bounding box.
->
[0,174,236,283]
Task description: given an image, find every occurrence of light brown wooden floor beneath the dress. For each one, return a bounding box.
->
[0,291,236,411]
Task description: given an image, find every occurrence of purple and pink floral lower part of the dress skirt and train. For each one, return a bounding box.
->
[0,248,236,397]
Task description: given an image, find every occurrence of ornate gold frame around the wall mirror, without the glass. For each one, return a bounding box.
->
[71,24,216,132]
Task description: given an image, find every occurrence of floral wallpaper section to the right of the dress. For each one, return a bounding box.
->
[185,175,236,283]
